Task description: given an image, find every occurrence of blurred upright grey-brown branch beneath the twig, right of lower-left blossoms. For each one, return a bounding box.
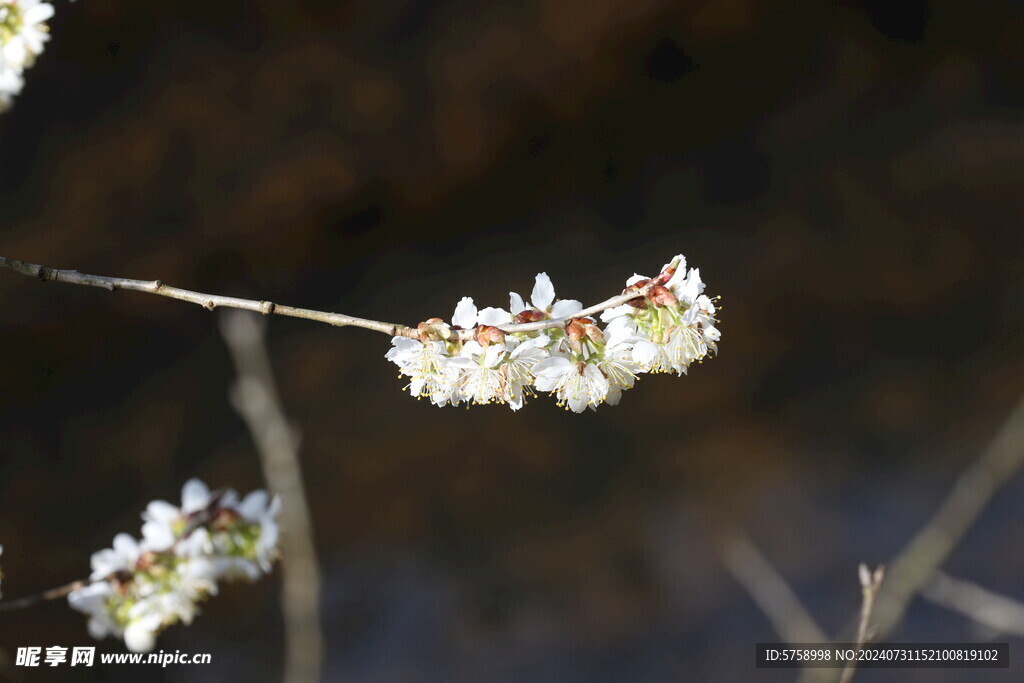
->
[221,312,324,683]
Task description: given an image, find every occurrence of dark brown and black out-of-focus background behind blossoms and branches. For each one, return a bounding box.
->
[0,0,1024,683]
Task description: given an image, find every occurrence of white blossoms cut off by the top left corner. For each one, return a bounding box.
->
[0,0,53,112]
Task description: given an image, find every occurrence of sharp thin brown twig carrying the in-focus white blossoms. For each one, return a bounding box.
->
[0,256,648,341]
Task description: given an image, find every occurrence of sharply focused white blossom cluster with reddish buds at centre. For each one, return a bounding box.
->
[386,254,721,413]
